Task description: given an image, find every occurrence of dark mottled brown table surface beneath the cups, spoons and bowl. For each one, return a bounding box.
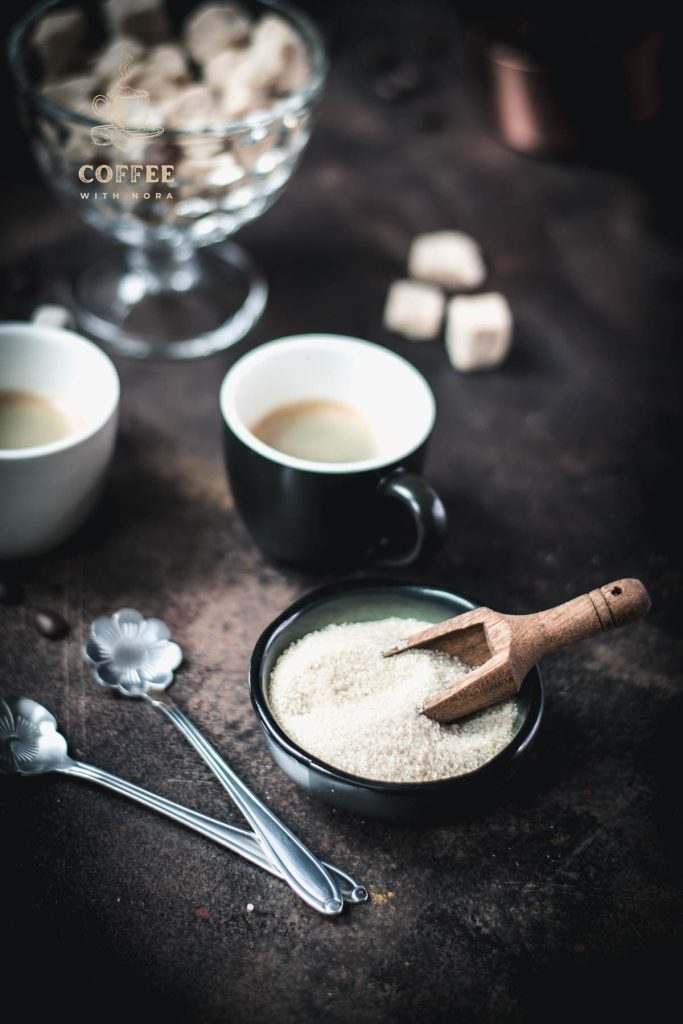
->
[0,4,683,1024]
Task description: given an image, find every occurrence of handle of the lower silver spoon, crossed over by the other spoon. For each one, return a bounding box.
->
[57,761,368,903]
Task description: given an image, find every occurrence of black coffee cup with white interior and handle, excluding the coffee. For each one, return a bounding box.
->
[220,334,445,569]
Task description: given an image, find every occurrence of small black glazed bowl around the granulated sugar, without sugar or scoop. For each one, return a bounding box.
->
[249,580,544,822]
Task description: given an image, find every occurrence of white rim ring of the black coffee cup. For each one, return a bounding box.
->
[219,333,436,475]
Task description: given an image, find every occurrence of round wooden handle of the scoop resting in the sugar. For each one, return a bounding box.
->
[522,580,650,658]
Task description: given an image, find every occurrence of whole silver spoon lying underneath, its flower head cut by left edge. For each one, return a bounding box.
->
[0,697,368,903]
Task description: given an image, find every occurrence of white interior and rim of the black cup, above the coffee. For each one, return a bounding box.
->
[220,334,436,473]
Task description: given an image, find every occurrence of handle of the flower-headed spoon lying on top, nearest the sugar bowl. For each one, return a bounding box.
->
[144,694,344,914]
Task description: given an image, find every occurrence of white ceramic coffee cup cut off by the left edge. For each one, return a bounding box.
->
[0,323,120,559]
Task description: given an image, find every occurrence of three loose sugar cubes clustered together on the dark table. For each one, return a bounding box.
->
[384,231,512,373]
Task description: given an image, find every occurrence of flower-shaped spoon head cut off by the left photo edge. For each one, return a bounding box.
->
[0,697,70,775]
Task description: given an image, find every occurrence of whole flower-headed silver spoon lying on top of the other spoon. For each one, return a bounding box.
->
[84,608,344,914]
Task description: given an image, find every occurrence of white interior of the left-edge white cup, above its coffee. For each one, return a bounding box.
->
[0,324,120,460]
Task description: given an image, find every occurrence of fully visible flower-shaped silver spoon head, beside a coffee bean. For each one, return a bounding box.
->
[83,608,182,697]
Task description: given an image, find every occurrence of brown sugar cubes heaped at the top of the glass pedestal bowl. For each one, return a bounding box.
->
[31,0,311,131]
